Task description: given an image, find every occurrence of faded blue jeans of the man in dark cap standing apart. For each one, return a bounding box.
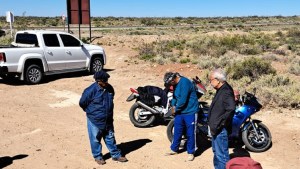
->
[87,118,121,160]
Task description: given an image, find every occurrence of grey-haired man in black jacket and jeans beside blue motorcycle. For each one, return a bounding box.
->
[208,69,235,169]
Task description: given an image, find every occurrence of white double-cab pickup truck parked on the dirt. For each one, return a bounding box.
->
[0,30,106,84]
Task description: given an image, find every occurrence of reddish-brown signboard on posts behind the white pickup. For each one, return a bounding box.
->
[67,0,90,24]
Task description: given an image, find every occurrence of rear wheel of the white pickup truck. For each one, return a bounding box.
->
[25,64,43,84]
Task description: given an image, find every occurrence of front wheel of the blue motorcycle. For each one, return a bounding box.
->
[242,122,272,152]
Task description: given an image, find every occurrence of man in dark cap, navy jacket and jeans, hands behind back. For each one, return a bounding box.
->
[79,71,127,165]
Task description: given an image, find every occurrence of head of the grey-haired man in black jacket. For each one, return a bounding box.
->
[209,69,227,89]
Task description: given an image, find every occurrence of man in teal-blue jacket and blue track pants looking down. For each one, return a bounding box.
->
[164,72,199,161]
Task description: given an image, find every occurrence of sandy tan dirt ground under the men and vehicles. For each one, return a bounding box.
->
[0,41,300,169]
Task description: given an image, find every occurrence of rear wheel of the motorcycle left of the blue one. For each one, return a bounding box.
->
[129,103,156,127]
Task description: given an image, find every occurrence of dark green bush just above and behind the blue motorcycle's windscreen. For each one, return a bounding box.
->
[227,57,276,81]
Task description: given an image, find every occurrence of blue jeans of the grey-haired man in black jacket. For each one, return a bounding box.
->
[212,128,229,169]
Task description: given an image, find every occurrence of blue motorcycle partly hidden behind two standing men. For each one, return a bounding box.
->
[167,92,272,152]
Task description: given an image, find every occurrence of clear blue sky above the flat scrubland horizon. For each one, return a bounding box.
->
[0,0,300,17]
